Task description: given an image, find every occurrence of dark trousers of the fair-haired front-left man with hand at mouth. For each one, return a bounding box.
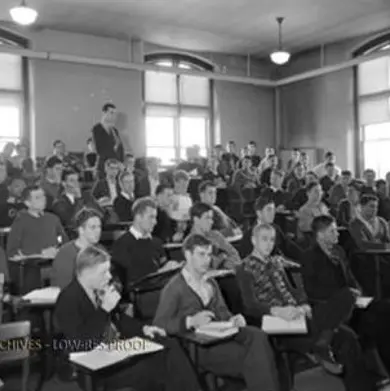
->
[104,338,200,391]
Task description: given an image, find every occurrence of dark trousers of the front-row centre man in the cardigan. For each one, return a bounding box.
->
[198,326,280,391]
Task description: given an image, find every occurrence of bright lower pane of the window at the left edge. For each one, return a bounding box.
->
[0,96,21,139]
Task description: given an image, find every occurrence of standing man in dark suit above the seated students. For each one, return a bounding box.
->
[92,103,124,175]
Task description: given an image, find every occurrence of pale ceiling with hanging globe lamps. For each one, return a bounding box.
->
[0,0,390,55]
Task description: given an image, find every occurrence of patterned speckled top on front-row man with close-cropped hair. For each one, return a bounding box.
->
[243,254,298,307]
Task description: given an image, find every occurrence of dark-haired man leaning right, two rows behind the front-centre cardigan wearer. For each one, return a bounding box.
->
[199,181,242,237]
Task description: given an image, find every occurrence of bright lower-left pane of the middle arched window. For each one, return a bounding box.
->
[146,117,175,147]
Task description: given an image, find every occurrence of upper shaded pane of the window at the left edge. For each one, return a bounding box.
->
[0,53,22,90]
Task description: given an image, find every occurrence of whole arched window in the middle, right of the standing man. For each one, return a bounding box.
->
[144,53,213,166]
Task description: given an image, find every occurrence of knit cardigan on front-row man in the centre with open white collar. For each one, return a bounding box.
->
[153,273,232,335]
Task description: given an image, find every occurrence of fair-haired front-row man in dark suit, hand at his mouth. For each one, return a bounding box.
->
[54,246,199,391]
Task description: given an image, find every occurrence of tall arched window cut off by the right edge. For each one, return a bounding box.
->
[354,34,390,178]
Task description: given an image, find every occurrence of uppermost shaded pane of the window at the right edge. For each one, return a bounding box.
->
[359,56,390,95]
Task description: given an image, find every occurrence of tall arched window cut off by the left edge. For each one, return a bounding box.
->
[0,28,28,151]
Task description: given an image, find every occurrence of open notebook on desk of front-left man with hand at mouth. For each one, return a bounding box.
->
[70,337,164,371]
